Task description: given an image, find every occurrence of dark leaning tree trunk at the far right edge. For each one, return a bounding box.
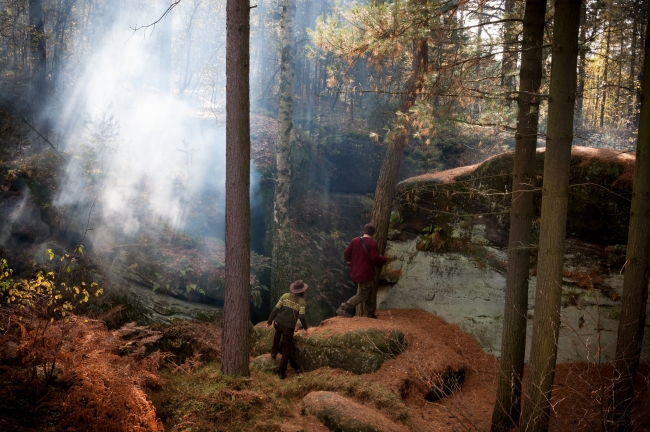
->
[608,6,650,432]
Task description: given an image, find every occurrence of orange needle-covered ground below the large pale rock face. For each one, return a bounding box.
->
[290,309,650,431]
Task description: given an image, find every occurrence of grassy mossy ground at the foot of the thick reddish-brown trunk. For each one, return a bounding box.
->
[147,362,409,432]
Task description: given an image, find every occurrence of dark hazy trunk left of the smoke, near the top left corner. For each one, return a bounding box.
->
[29,0,48,137]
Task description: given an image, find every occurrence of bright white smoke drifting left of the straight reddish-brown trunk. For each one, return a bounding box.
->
[53,2,246,246]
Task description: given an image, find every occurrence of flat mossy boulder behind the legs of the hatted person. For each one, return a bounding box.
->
[250,318,406,374]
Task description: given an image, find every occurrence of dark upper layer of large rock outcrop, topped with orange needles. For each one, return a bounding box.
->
[396,147,635,246]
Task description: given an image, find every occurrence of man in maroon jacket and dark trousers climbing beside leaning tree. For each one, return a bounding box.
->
[336,224,387,318]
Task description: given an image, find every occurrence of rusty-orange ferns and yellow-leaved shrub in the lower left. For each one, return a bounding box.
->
[0,260,165,431]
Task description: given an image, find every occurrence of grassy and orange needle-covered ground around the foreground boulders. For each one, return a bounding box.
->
[147,310,650,431]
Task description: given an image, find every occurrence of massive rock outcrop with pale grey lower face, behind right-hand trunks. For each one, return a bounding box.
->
[378,147,650,362]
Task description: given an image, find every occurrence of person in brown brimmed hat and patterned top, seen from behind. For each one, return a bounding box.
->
[266,280,309,379]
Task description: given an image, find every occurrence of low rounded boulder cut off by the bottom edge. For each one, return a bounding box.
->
[303,391,407,432]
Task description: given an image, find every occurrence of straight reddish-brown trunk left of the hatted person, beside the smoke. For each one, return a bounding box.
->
[221,0,251,376]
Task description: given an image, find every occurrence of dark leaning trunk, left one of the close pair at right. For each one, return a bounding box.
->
[492,0,546,431]
